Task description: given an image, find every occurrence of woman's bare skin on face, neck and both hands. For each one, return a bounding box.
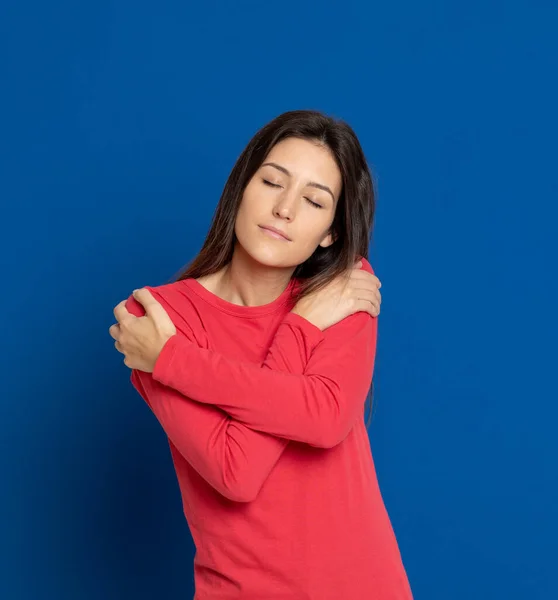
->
[109,138,381,373]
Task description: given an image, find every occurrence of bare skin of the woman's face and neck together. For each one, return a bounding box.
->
[199,138,342,306]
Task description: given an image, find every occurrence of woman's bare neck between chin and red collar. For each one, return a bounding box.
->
[213,243,295,306]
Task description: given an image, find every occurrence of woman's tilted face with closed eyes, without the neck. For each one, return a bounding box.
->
[235,138,342,267]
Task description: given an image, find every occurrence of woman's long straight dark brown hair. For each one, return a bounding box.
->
[173,110,376,426]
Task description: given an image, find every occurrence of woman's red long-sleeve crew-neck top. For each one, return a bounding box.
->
[127,261,412,600]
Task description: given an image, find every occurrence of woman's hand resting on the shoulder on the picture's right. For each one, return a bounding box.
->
[292,261,382,331]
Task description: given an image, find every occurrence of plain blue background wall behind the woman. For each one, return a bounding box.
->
[0,0,558,600]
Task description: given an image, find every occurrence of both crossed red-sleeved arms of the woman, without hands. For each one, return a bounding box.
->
[126,290,377,501]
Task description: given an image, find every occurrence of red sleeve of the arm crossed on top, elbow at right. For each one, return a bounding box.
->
[153,312,378,448]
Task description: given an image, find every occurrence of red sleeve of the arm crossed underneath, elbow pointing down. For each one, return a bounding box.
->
[126,296,320,502]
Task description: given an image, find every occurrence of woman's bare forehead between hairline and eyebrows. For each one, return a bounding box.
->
[263,138,343,197]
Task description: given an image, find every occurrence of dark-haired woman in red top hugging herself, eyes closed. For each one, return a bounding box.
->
[110,111,412,600]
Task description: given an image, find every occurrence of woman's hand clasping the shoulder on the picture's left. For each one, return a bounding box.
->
[109,288,176,373]
